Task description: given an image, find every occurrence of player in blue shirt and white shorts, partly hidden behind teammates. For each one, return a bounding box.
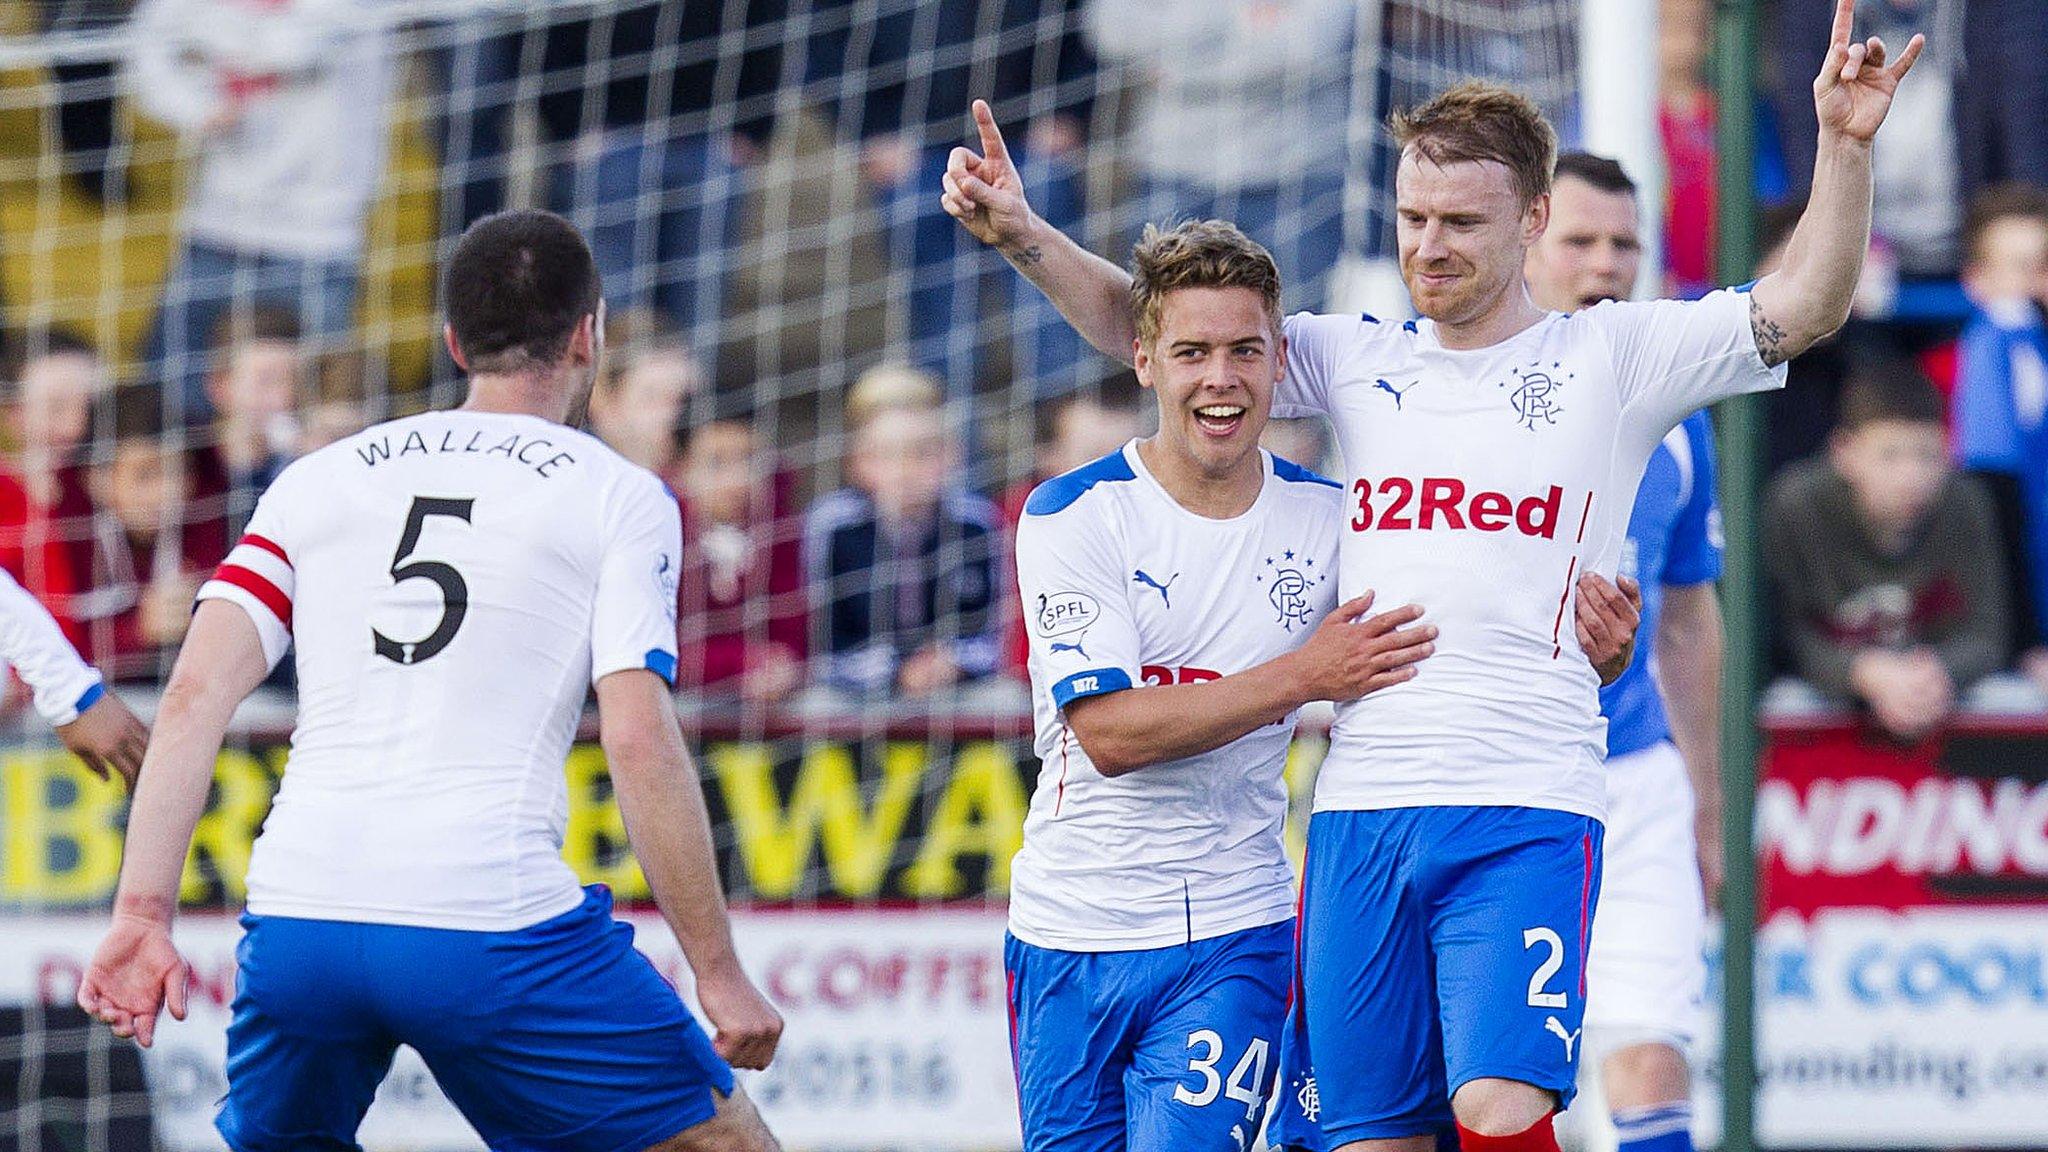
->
[1526,152,1720,1152]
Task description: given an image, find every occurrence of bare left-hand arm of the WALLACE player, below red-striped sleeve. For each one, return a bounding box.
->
[78,601,270,1047]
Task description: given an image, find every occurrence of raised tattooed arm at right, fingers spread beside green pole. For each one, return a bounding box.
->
[1749,0,1927,365]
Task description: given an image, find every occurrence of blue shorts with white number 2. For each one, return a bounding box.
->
[1268,808,1602,1152]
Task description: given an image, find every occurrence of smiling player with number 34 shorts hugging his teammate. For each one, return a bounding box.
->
[1006,221,1634,1152]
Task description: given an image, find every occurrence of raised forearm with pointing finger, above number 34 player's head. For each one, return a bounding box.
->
[940,100,1137,365]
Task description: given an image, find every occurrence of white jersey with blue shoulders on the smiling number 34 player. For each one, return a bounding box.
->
[1010,441,1341,951]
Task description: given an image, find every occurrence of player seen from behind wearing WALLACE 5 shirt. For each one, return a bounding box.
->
[78,211,782,1152]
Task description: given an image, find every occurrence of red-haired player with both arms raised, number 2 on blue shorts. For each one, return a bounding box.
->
[944,0,1923,1152]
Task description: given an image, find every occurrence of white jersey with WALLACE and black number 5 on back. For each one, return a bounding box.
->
[199,412,682,931]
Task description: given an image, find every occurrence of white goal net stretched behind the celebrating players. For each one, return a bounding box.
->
[0,0,1579,1152]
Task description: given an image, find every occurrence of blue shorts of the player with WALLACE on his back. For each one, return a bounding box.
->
[215,886,733,1152]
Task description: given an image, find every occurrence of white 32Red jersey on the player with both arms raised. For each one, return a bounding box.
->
[1274,289,1786,818]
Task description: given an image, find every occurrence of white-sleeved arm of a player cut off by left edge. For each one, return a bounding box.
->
[0,572,150,789]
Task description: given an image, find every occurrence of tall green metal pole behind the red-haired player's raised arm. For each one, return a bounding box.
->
[1714,0,1763,1152]
